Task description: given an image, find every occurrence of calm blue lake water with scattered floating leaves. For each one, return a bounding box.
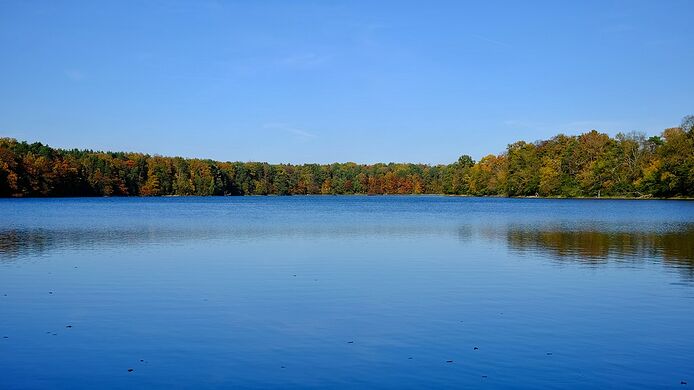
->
[0,200,694,389]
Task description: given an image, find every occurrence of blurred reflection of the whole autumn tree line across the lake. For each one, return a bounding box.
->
[5,224,694,272]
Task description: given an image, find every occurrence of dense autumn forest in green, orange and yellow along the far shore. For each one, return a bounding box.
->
[0,116,694,197]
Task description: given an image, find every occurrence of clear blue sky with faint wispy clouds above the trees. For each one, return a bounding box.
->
[0,0,694,164]
